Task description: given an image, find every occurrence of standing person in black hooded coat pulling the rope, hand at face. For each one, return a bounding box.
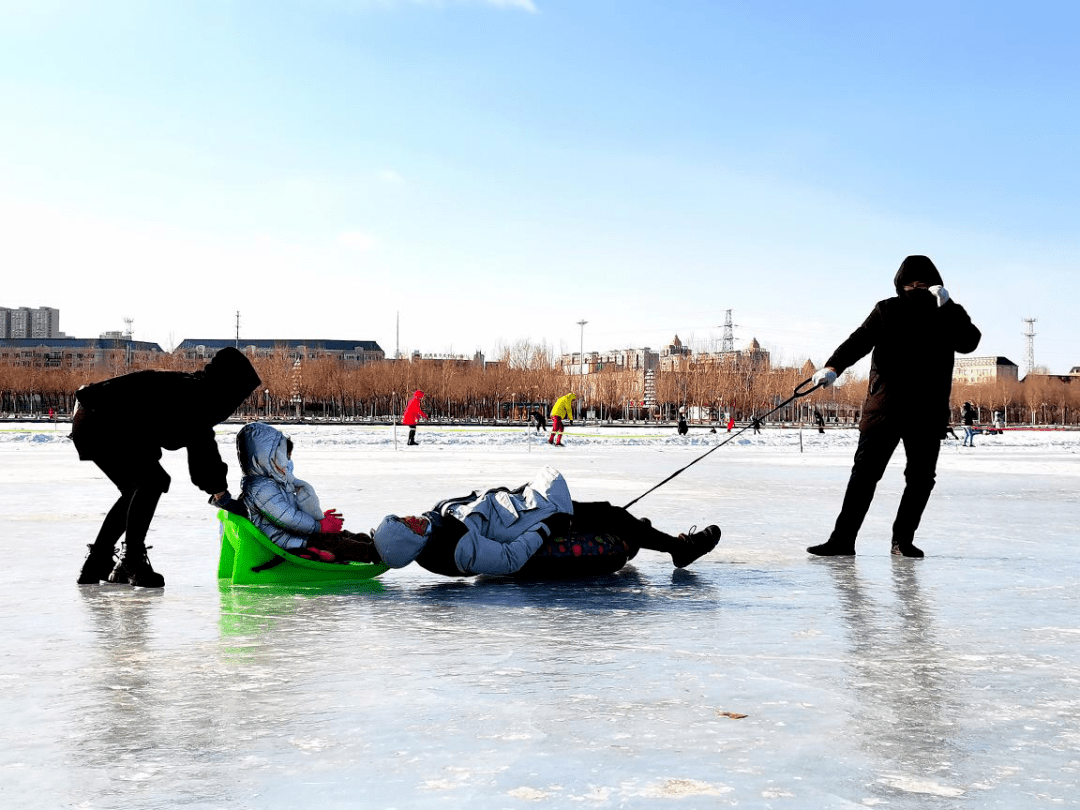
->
[807,256,982,557]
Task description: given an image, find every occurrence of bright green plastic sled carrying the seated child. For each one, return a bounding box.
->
[217,509,389,585]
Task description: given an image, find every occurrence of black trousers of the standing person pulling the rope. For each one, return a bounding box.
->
[829,424,941,548]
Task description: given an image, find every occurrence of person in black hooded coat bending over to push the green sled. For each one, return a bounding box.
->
[71,348,259,588]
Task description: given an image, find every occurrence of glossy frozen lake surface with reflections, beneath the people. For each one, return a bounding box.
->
[0,424,1080,810]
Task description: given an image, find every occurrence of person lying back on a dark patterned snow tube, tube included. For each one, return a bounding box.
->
[372,467,720,578]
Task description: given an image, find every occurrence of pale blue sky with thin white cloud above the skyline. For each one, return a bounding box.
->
[0,0,1080,374]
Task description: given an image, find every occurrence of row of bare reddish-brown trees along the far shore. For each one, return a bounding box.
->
[0,341,1080,432]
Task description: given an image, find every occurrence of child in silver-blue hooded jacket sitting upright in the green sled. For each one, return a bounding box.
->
[237,422,378,563]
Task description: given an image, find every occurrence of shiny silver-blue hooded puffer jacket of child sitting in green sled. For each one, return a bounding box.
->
[237,422,323,550]
